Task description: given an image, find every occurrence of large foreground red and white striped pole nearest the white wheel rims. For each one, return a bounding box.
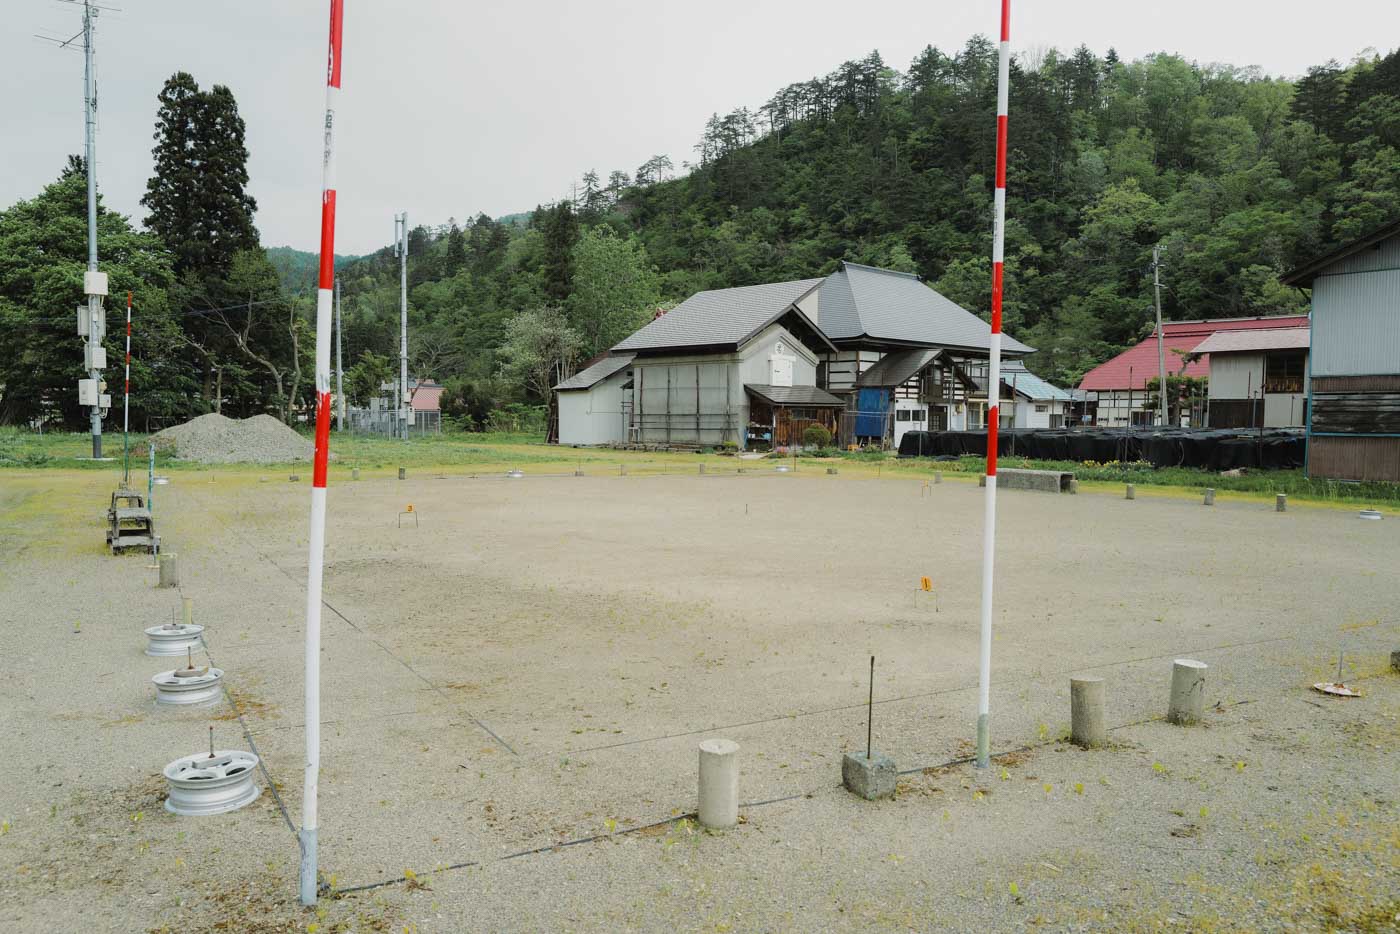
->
[300,0,344,905]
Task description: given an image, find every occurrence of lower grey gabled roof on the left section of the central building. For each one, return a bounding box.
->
[613,279,822,353]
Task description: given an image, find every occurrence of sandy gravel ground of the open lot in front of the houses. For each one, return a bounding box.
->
[0,471,1400,931]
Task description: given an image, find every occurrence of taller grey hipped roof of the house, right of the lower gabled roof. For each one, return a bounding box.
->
[818,262,1033,354]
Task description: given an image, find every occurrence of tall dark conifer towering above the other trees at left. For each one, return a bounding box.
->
[141,71,258,276]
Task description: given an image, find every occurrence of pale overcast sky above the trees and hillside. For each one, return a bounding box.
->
[0,0,1400,253]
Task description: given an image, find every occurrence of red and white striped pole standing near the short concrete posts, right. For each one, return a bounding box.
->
[977,0,1011,769]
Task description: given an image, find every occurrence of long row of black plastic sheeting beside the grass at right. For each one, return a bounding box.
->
[899,428,1305,471]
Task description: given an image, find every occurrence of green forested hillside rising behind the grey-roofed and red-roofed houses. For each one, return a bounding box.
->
[333,38,1400,422]
